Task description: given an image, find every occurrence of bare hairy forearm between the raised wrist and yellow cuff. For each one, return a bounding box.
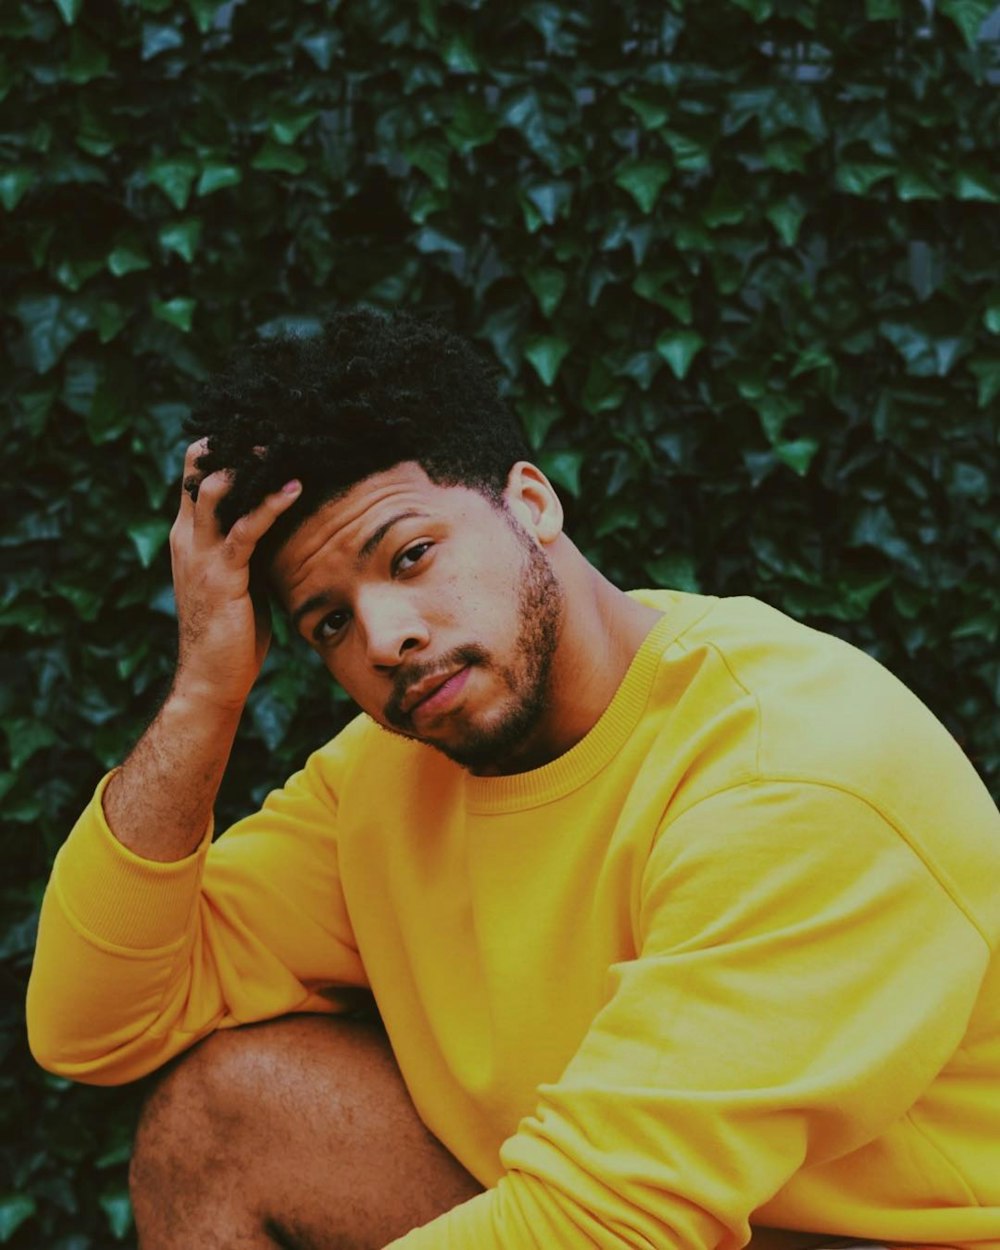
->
[104,688,241,863]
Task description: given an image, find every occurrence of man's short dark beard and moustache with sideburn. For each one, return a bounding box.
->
[384,516,564,773]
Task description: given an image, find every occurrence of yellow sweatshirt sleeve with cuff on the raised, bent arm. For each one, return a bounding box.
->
[28,740,365,1085]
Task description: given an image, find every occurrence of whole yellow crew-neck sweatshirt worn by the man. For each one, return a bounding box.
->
[29,591,1000,1250]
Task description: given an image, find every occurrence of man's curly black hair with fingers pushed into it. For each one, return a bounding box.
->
[185,309,529,551]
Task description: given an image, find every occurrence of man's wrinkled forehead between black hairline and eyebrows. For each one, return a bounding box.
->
[270,461,494,600]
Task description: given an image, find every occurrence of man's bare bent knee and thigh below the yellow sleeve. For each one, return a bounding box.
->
[131,1016,481,1250]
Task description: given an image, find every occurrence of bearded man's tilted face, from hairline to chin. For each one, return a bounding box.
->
[271,463,563,771]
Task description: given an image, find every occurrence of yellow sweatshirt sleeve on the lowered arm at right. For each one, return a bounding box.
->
[391,783,989,1250]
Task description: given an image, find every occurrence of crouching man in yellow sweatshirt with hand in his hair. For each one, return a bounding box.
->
[29,305,1000,1250]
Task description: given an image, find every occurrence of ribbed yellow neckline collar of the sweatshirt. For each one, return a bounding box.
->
[465,590,711,815]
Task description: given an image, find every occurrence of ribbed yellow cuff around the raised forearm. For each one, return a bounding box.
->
[51,773,211,954]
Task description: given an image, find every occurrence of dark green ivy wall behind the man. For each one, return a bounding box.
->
[0,0,1000,1250]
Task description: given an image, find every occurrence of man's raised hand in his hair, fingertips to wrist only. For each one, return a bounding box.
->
[170,443,301,709]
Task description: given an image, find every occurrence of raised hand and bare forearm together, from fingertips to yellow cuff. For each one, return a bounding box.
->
[104,443,300,861]
